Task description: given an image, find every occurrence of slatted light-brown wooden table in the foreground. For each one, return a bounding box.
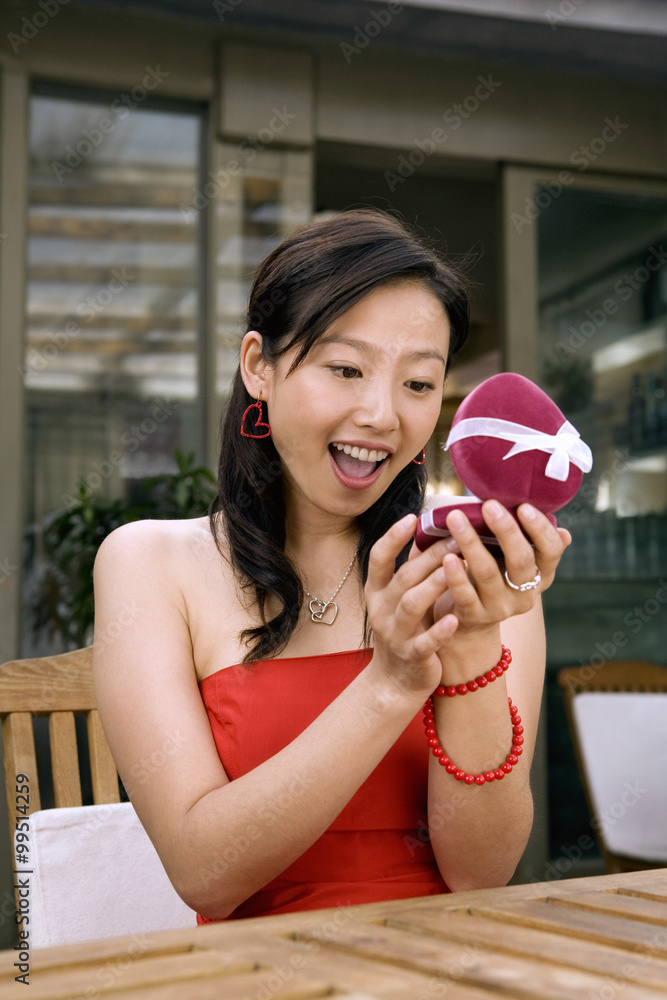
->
[0,869,667,1000]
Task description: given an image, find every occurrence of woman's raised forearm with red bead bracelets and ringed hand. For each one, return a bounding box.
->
[422,507,569,891]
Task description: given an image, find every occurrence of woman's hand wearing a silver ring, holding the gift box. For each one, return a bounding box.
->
[424,500,572,631]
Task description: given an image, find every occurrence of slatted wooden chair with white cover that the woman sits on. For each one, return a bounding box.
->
[0,647,196,947]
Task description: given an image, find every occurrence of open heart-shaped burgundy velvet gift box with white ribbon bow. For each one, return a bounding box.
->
[415,372,593,557]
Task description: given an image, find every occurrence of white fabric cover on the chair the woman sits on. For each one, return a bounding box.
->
[16,802,197,948]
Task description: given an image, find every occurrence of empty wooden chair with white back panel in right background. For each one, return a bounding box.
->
[558,660,667,874]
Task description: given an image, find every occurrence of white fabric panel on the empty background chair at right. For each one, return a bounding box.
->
[573,691,667,862]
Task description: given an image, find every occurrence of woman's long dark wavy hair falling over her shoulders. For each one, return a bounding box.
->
[208,209,468,663]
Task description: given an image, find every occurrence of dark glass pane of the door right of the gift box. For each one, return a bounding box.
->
[538,187,667,584]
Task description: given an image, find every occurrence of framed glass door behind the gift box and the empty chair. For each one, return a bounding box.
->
[503,168,667,879]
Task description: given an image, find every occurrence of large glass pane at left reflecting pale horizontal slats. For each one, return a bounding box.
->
[21,85,204,656]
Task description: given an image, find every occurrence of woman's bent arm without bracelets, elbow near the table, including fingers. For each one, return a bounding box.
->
[94,518,448,918]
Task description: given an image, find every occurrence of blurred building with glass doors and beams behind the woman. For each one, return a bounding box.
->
[0,0,667,920]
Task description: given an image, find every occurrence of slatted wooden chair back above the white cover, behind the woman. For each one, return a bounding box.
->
[0,646,120,840]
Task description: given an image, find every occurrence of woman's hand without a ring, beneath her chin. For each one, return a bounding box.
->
[365,514,459,697]
